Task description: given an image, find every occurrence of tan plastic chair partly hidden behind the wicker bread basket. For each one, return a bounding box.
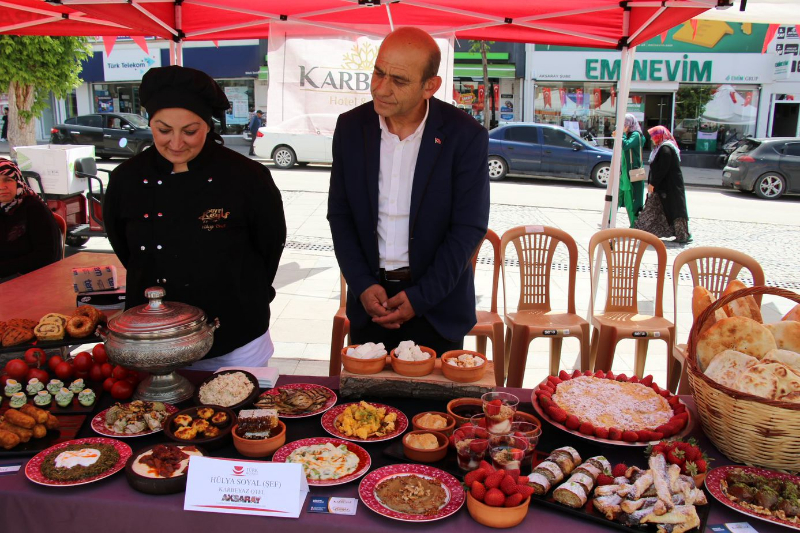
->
[668,246,765,394]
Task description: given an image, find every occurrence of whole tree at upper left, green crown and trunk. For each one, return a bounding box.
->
[0,35,92,157]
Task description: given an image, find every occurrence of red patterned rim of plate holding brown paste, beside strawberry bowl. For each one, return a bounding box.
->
[358,464,466,522]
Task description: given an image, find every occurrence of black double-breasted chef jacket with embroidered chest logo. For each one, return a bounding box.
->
[103,138,286,359]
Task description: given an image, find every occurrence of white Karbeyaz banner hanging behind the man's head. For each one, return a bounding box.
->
[267,22,453,133]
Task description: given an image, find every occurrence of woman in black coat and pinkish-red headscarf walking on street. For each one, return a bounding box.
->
[635,126,692,244]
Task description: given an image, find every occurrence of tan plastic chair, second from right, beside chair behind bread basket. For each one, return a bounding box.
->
[589,228,675,382]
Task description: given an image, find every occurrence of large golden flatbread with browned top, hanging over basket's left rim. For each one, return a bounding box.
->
[697,316,778,372]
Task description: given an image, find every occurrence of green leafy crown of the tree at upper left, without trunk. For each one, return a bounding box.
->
[0,35,92,121]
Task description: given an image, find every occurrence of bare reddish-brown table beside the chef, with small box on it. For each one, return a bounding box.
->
[0,252,126,321]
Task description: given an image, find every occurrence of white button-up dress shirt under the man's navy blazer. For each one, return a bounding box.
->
[378,100,429,270]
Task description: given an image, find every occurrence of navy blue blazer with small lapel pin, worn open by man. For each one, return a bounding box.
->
[328,98,489,340]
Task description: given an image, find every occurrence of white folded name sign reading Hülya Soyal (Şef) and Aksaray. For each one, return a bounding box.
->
[183,457,308,518]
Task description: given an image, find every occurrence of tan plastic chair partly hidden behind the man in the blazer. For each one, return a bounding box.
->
[467,230,508,387]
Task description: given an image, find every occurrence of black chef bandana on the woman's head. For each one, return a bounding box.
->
[139,65,230,125]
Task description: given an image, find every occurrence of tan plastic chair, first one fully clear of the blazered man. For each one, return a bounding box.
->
[500,226,590,387]
